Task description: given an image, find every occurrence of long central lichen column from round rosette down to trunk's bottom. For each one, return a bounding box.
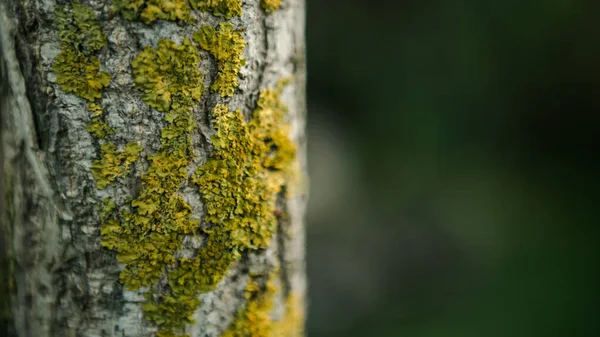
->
[102,39,204,336]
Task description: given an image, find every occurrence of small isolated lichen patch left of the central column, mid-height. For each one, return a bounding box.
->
[92,142,142,189]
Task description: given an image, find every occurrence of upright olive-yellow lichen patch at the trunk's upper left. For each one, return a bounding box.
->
[52,2,110,101]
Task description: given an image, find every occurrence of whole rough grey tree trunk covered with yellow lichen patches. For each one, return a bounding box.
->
[0,0,307,337]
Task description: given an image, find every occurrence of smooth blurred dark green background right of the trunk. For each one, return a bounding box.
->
[307,0,600,337]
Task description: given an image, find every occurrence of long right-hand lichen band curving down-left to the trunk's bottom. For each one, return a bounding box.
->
[145,105,275,332]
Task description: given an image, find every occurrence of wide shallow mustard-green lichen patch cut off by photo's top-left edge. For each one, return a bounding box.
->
[114,0,191,24]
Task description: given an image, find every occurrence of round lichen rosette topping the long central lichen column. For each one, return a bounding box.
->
[132,39,204,111]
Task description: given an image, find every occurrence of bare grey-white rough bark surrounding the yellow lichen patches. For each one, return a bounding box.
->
[0,0,306,337]
